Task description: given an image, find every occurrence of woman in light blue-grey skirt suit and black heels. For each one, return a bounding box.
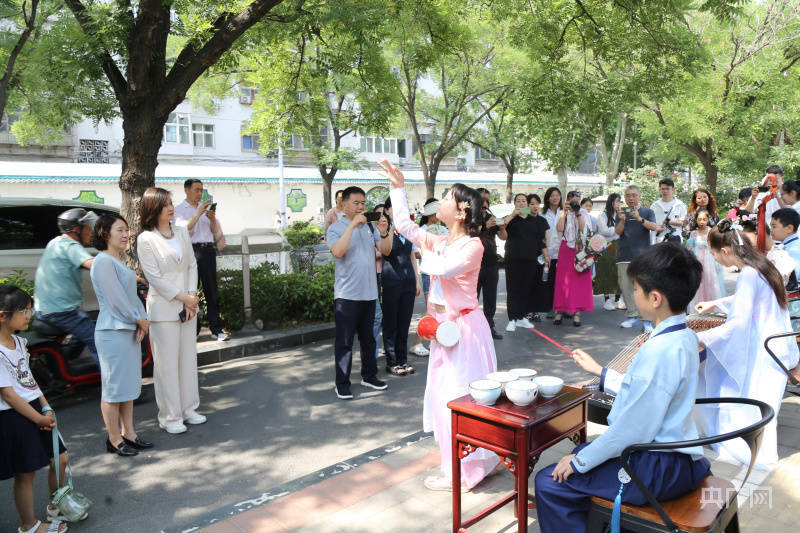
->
[90,214,153,457]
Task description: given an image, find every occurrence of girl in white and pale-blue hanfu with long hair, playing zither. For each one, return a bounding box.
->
[696,219,800,469]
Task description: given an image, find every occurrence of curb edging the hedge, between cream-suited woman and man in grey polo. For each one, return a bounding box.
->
[197,322,336,366]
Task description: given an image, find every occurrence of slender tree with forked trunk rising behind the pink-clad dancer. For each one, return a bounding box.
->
[389,2,508,197]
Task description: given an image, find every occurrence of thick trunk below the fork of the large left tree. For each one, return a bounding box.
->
[119,106,167,270]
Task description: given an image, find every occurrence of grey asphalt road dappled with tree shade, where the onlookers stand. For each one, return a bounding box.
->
[0,273,724,533]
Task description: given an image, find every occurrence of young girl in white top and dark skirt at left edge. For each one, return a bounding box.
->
[0,285,68,533]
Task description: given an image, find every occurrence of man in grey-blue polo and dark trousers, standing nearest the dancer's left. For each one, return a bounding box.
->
[327,187,392,400]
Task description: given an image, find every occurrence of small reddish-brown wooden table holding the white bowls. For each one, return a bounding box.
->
[447,386,591,533]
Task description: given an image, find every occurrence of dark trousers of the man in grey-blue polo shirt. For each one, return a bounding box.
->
[333,298,378,386]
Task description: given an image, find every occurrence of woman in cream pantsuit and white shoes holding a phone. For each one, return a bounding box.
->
[136,187,206,433]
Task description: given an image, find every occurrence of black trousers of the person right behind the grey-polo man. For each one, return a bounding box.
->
[382,280,417,366]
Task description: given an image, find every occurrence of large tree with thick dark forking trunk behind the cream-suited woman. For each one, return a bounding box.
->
[15,0,307,241]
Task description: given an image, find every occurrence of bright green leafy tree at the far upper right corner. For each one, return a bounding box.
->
[637,0,800,192]
